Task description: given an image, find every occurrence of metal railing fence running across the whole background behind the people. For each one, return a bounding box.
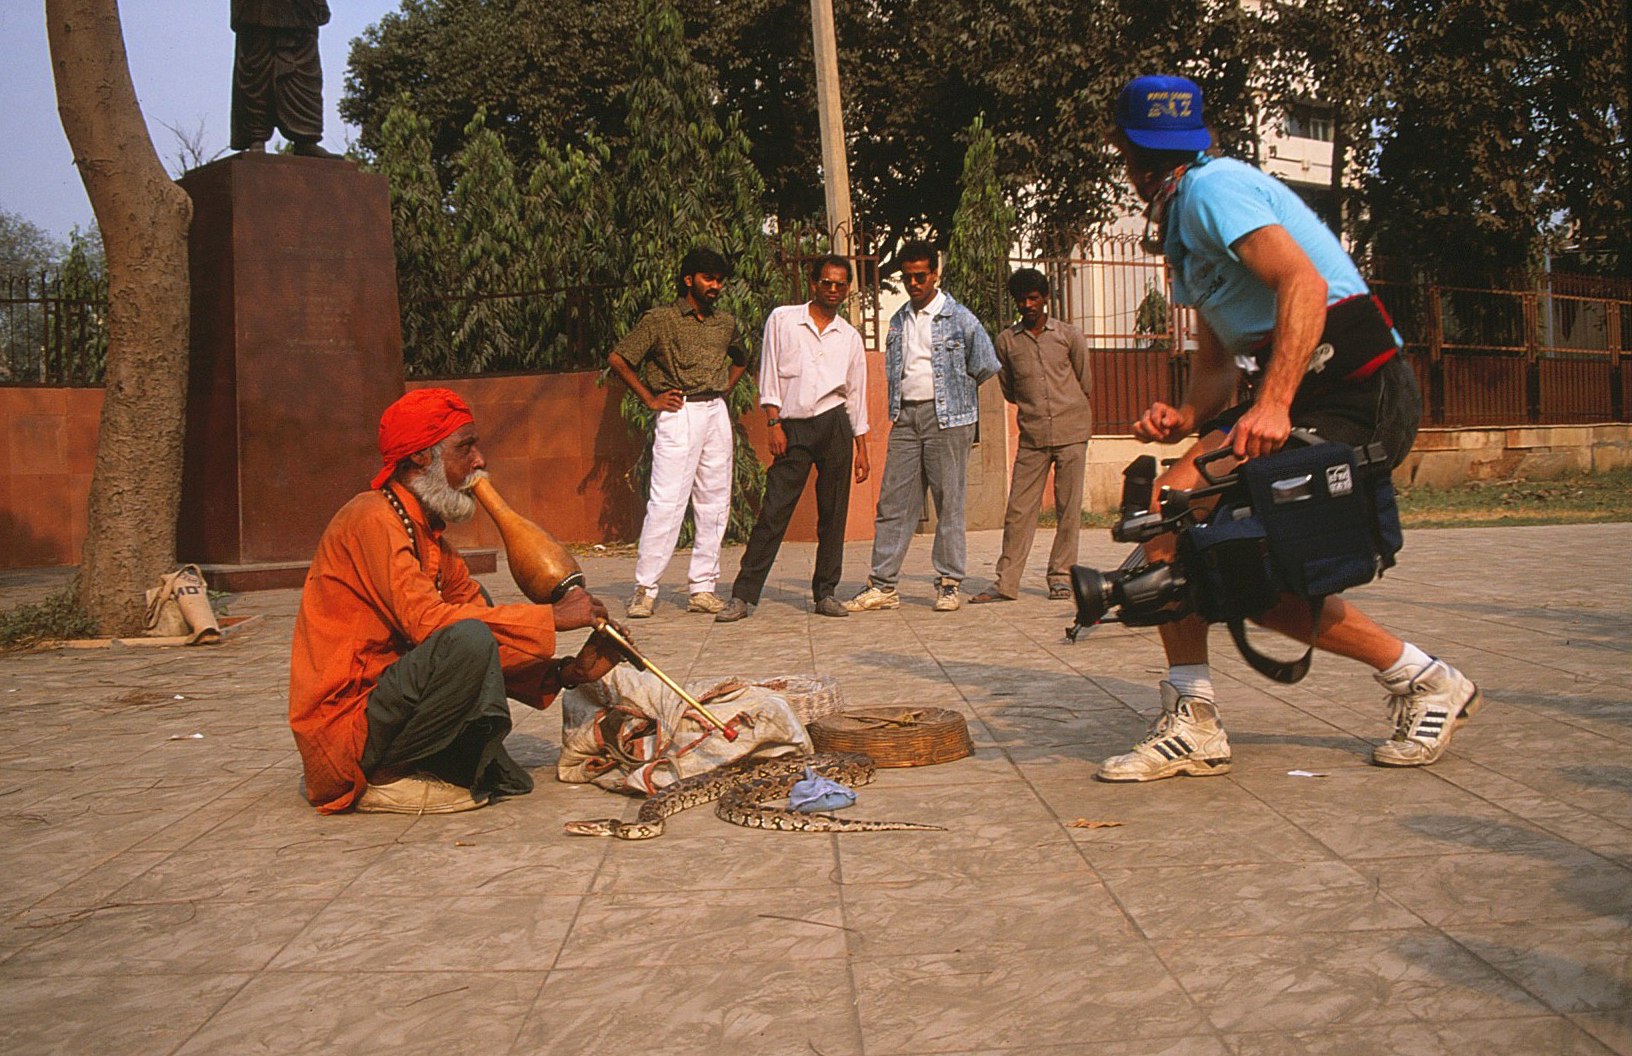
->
[9,233,1632,433]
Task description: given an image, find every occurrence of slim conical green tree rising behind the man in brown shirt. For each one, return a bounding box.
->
[942,116,1015,333]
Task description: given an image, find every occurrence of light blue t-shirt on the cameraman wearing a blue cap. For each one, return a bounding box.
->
[1165,158,1369,354]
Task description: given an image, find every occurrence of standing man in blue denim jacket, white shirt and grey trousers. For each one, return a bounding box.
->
[844,242,999,612]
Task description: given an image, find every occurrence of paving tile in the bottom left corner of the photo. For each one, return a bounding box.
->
[0,973,250,1056]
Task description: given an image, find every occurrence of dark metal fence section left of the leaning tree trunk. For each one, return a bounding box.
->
[0,273,108,385]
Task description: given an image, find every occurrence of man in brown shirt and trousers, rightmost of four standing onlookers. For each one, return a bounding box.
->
[969,268,1093,606]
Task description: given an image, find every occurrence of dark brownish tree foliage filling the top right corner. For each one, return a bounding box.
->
[1366,0,1632,281]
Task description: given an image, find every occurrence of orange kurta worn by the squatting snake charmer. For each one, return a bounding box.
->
[289,483,558,814]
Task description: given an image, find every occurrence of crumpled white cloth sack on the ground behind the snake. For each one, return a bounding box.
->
[555,664,811,795]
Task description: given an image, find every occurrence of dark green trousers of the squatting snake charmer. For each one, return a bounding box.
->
[361,620,532,795]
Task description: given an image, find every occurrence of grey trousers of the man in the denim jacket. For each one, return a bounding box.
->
[871,400,974,589]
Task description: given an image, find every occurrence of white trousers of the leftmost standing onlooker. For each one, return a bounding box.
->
[635,398,733,594]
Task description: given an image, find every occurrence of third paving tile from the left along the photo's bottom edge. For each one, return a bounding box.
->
[509,959,875,1056]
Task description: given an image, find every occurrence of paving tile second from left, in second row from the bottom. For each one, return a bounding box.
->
[269,894,579,973]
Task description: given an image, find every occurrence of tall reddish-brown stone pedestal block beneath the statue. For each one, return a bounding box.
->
[176,153,403,588]
